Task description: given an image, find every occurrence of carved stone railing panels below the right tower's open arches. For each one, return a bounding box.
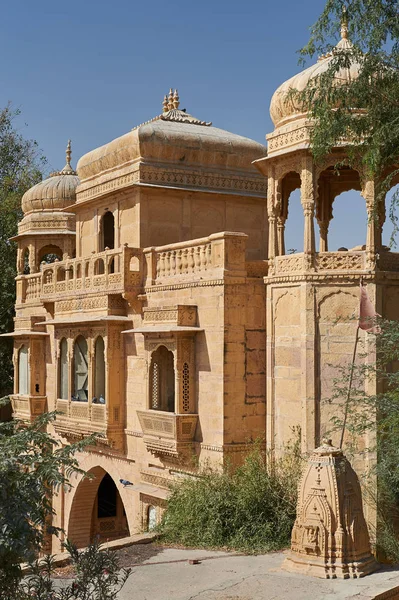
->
[274,251,366,276]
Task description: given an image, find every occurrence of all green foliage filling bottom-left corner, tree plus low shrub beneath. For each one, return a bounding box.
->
[0,406,129,600]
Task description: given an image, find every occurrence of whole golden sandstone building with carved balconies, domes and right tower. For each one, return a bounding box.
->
[5,28,399,552]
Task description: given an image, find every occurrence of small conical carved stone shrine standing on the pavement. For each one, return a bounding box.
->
[284,440,378,579]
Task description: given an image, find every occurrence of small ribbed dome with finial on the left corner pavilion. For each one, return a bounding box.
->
[22,140,79,214]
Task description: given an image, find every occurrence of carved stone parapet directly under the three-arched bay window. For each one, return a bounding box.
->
[55,399,107,435]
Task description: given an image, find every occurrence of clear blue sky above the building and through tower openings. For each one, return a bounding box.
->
[0,0,394,249]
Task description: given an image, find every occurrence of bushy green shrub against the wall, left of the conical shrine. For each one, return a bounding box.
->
[160,442,301,552]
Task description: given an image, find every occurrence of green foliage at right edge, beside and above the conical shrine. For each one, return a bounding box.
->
[328,319,399,562]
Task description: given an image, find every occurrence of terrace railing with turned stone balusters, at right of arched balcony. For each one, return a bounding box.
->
[144,232,247,286]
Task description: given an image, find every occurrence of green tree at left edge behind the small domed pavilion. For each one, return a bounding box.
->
[0,104,45,396]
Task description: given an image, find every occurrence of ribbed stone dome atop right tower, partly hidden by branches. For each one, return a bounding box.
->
[270,22,360,127]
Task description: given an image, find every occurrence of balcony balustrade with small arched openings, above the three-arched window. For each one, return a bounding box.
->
[40,247,142,300]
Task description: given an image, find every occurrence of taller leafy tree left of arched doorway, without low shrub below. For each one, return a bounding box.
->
[0,401,93,594]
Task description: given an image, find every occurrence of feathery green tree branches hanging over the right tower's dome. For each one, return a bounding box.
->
[293,0,399,185]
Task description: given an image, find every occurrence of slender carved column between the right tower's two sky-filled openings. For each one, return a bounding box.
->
[301,155,315,270]
